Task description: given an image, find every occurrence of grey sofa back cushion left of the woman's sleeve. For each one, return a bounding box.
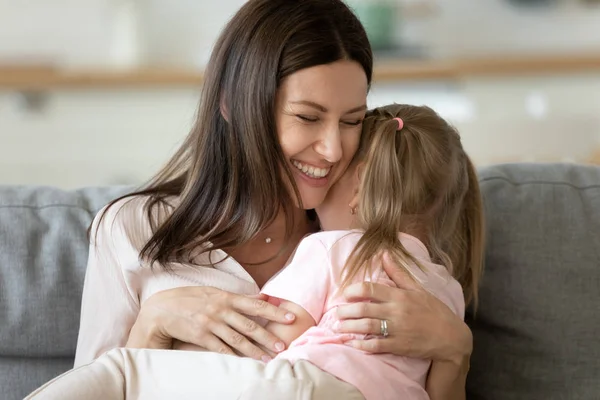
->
[0,186,130,399]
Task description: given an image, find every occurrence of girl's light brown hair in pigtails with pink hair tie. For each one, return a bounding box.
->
[344,104,484,306]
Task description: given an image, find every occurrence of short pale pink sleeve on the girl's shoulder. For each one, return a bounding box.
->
[262,236,331,324]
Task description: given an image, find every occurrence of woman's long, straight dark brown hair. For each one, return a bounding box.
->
[95,0,373,268]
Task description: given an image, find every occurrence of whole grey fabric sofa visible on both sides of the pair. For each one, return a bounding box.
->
[0,164,600,400]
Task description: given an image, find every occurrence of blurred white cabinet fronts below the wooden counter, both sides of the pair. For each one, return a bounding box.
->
[0,74,600,187]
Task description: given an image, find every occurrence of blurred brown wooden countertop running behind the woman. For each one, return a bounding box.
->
[0,52,600,91]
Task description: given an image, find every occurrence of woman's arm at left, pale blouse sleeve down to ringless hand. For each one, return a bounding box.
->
[75,200,295,366]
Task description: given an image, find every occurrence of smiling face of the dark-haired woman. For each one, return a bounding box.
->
[276,60,369,209]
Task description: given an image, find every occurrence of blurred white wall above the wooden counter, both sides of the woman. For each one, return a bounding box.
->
[0,0,600,66]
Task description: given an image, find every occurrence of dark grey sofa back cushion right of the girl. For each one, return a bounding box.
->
[467,165,600,400]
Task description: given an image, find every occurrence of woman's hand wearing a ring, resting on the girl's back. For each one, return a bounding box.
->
[338,256,473,366]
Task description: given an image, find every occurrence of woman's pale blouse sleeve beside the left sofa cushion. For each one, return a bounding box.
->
[75,203,139,367]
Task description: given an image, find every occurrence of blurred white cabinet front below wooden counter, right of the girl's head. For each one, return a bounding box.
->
[370,73,600,165]
